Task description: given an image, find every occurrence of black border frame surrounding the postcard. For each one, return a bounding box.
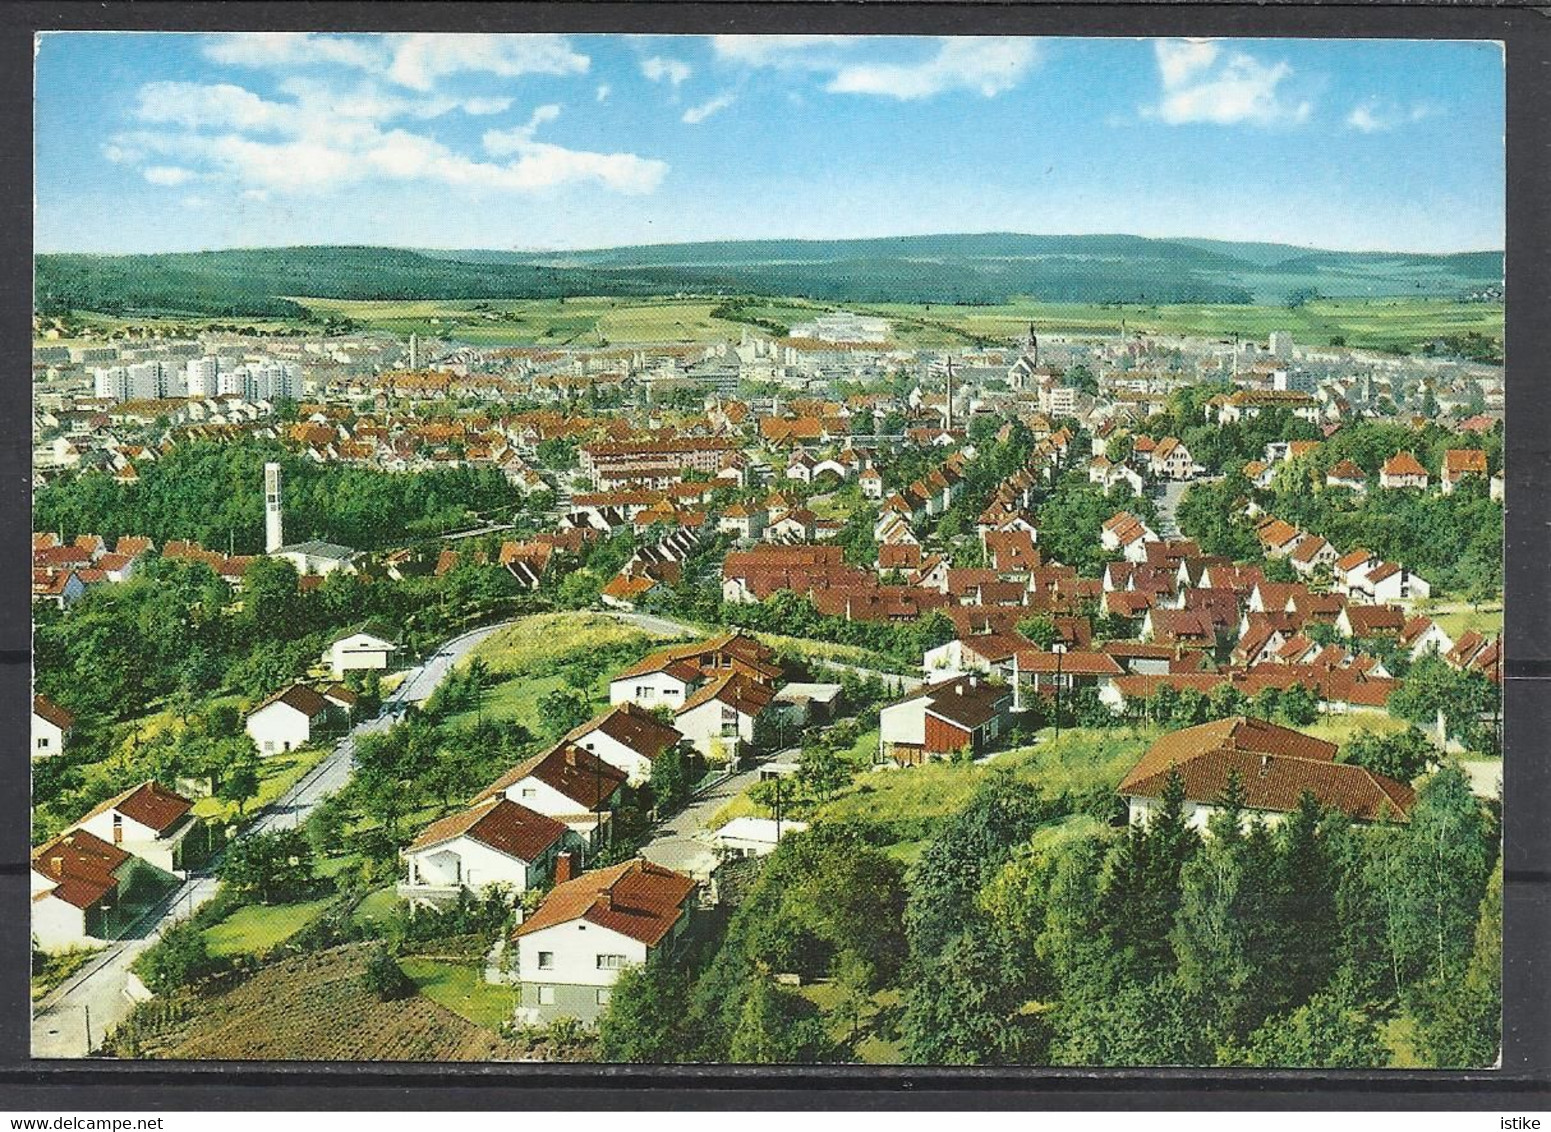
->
[0,0,1551,1112]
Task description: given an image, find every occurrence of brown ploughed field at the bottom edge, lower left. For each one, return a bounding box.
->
[141,944,515,1061]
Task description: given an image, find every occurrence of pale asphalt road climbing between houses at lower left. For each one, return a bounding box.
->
[33,622,510,1058]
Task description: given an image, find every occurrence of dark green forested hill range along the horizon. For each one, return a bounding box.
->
[36,233,1503,316]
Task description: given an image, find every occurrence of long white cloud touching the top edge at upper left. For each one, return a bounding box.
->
[193,31,591,91]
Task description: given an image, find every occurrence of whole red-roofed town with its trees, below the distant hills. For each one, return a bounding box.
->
[31,296,1504,1065]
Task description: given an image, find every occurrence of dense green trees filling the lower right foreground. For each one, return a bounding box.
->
[600,768,1501,1068]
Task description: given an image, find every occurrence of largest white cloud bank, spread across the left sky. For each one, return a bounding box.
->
[104,82,668,194]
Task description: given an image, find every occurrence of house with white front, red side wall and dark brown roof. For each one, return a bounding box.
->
[878,673,1013,764]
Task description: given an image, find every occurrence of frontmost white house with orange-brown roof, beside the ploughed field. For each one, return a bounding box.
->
[510,858,698,1025]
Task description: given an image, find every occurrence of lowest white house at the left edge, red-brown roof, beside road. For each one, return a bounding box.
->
[31,830,143,951]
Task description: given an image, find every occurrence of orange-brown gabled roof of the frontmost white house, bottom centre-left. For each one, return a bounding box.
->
[512,858,695,947]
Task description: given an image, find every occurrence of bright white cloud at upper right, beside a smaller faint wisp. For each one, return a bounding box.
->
[1143,40,1314,126]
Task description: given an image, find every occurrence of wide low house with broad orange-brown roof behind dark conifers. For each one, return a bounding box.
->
[1120,715,1416,831]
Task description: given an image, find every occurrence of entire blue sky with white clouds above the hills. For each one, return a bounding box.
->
[34,33,1504,253]
